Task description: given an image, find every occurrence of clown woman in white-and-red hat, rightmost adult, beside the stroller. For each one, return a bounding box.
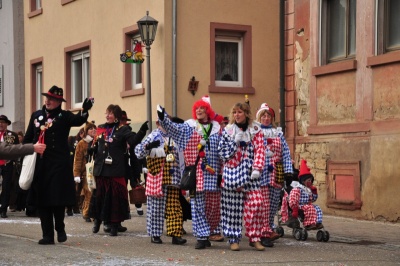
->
[256,103,293,247]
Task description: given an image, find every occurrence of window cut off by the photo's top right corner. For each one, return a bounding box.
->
[376,0,400,54]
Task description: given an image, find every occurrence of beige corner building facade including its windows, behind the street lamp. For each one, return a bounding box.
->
[24,0,279,132]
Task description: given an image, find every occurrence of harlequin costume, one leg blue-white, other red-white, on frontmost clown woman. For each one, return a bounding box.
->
[218,122,265,249]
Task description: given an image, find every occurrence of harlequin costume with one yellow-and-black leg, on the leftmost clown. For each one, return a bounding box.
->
[135,125,186,244]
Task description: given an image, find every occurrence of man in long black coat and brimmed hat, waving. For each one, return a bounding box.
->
[24,86,93,245]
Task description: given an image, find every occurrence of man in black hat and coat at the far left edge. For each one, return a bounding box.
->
[0,115,19,218]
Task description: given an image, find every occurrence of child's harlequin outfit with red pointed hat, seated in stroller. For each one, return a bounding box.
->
[289,160,322,229]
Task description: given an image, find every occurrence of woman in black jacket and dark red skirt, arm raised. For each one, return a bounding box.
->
[90,104,149,236]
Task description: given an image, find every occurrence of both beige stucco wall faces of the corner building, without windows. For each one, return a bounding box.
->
[24,0,279,129]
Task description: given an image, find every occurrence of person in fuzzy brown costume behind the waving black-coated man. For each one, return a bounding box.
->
[74,122,97,222]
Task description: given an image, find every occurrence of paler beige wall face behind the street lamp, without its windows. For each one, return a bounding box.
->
[24,0,170,131]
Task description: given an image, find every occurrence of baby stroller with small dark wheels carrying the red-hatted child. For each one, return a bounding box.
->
[275,169,330,242]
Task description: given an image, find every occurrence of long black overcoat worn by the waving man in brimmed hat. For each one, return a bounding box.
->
[24,107,88,206]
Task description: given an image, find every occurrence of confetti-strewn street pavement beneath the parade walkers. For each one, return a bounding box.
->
[0,206,400,266]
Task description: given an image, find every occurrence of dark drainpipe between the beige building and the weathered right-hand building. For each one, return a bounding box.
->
[279,0,286,134]
